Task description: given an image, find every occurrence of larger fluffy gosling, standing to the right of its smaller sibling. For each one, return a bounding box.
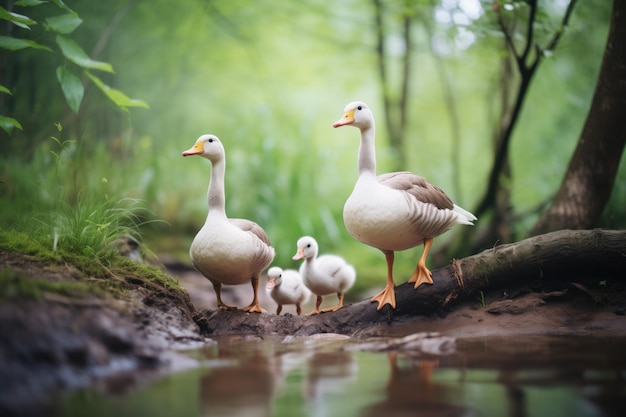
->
[293,236,356,315]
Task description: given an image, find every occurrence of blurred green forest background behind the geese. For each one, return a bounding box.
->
[0,0,626,296]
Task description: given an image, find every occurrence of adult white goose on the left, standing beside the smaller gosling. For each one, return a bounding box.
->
[183,135,274,313]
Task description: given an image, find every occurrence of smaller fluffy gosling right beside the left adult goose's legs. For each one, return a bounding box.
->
[265,266,311,315]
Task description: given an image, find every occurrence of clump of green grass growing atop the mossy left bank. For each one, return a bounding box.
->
[5,124,154,257]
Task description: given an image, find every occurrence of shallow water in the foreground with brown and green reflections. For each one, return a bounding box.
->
[52,335,626,417]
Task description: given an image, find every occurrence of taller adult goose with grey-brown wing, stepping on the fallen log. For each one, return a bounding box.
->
[333,101,476,310]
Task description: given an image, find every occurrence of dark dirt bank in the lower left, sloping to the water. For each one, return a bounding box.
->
[0,252,205,416]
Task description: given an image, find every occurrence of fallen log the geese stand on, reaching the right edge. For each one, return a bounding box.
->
[195,229,626,335]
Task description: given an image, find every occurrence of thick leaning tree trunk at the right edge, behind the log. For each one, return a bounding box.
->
[532,0,626,235]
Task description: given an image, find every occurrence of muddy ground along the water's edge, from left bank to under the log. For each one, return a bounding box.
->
[0,249,626,416]
